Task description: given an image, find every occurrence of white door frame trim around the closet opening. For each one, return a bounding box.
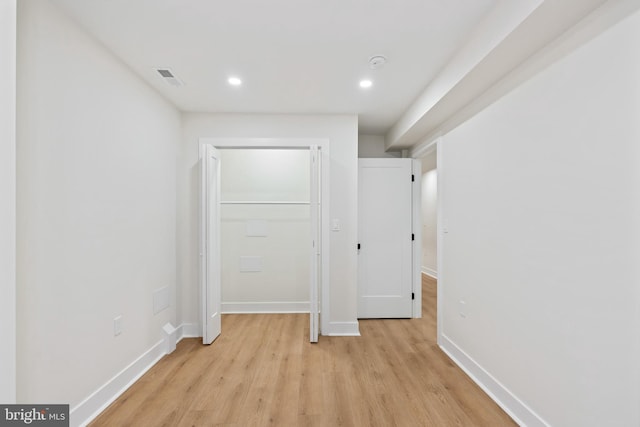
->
[198,137,331,334]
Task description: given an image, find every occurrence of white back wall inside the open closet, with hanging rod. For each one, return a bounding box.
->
[220,149,311,313]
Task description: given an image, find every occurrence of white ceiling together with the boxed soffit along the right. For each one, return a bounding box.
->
[49,0,616,145]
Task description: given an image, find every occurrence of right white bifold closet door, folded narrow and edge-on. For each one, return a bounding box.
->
[309,146,322,342]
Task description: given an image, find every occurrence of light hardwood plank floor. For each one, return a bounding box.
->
[91,276,516,427]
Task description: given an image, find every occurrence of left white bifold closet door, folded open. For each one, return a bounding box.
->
[200,145,222,344]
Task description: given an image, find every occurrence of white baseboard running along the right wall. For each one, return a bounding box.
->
[438,335,549,427]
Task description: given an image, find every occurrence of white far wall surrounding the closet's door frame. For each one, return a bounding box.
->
[178,114,358,334]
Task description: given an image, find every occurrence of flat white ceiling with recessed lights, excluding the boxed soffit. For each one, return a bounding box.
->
[52,0,499,134]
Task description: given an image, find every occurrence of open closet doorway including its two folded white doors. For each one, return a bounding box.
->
[200,138,330,344]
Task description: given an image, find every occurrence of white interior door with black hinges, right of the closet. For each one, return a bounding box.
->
[358,159,413,318]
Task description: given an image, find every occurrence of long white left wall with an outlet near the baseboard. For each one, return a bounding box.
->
[17,0,181,410]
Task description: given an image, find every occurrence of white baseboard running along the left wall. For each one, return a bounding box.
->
[69,339,165,426]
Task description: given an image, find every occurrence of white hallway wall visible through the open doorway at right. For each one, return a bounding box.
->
[420,151,438,278]
